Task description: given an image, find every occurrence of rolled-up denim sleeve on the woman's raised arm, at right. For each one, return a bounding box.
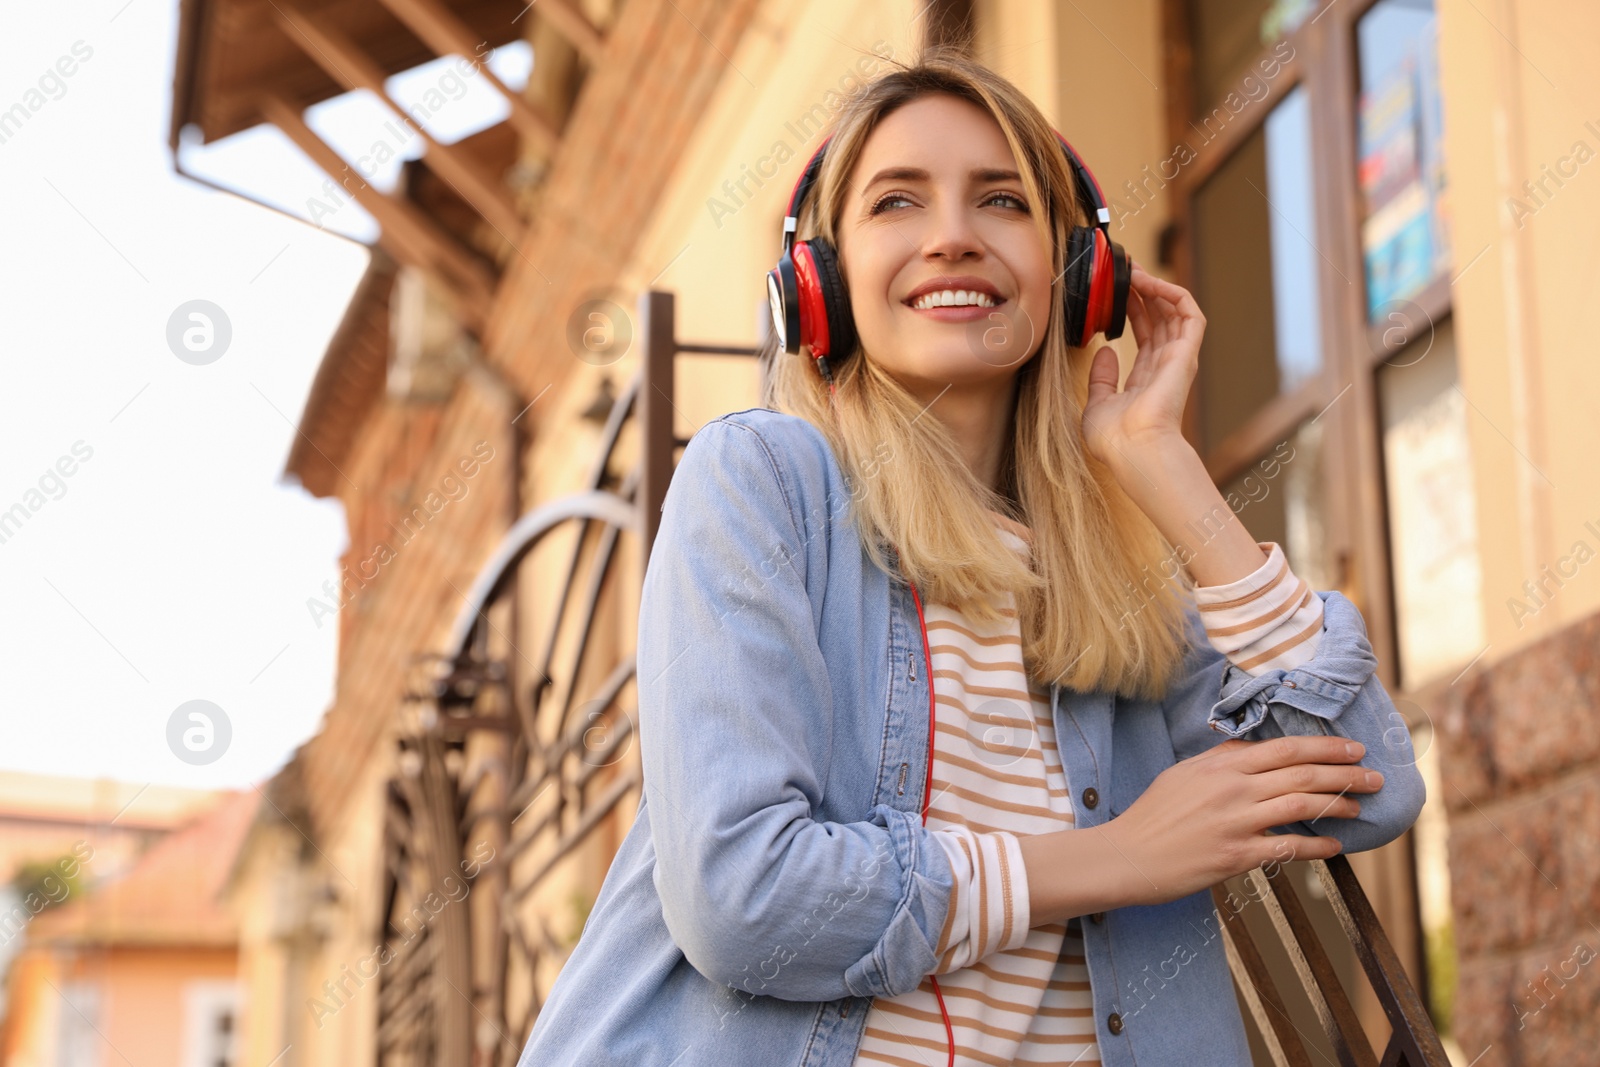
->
[1162,590,1426,853]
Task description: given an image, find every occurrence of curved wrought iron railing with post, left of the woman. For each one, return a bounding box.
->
[378,291,755,1067]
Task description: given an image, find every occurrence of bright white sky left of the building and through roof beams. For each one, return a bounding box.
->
[0,0,531,789]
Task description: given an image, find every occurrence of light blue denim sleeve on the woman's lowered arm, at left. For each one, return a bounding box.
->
[637,419,955,1001]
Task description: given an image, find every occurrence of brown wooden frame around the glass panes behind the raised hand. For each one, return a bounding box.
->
[1162,0,1451,691]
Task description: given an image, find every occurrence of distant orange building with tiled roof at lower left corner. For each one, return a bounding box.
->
[0,779,252,1067]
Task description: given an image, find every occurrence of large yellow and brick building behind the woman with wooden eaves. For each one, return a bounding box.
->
[159,0,1600,1067]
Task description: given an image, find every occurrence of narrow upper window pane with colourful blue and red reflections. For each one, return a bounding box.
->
[1357,0,1450,322]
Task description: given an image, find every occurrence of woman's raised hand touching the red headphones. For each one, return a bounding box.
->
[1083,262,1205,467]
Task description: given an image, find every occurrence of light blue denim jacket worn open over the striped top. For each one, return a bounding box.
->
[518,408,1424,1067]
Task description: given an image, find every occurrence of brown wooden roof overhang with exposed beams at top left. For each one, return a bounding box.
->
[170,0,605,333]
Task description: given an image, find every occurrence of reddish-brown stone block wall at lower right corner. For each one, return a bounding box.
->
[1434,604,1600,1067]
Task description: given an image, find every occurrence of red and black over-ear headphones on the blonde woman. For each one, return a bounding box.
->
[766,131,1131,386]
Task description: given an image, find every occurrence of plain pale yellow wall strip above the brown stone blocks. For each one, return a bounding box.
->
[1440,0,1600,664]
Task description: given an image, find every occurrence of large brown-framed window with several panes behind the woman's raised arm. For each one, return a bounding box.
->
[1163,0,1482,1062]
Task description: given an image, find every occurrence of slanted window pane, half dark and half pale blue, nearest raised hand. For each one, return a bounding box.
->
[1194,88,1322,451]
